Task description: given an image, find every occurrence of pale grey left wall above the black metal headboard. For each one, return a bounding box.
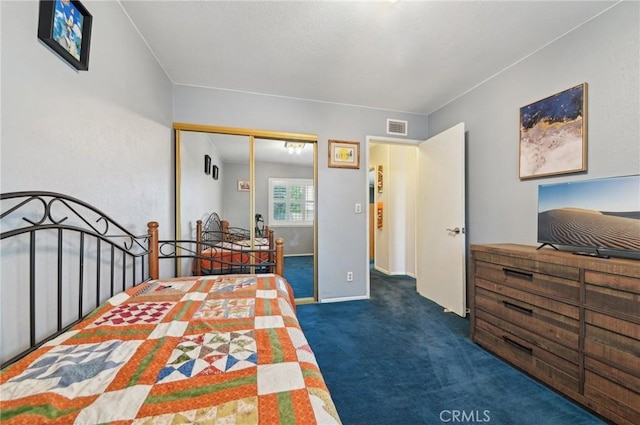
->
[0,1,174,237]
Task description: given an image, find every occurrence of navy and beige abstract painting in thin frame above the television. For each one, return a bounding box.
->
[519,83,587,179]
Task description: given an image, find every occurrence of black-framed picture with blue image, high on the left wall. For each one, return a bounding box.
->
[38,0,93,71]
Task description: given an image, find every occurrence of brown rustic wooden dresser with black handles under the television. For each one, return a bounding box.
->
[469,244,640,425]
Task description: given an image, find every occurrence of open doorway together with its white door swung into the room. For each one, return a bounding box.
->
[367,123,467,317]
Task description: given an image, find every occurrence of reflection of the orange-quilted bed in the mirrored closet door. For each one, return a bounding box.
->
[193,212,282,276]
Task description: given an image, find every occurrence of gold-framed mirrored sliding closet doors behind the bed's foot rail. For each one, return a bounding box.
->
[174,123,317,303]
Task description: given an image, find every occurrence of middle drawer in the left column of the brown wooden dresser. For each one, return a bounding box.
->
[474,279,580,349]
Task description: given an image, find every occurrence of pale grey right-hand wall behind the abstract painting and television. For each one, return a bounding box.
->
[429,2,640,245]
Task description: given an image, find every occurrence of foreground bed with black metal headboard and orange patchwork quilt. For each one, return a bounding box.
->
[0,192,340,424]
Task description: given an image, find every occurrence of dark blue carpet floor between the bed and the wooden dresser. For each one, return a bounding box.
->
[297,270,604,425]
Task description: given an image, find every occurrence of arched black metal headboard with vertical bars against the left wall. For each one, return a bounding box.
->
[0,191,149,367]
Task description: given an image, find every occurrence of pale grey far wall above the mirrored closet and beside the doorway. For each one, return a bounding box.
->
[173,86,427,301]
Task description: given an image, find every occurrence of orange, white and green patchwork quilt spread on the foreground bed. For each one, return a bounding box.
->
[0,274,340,425]
